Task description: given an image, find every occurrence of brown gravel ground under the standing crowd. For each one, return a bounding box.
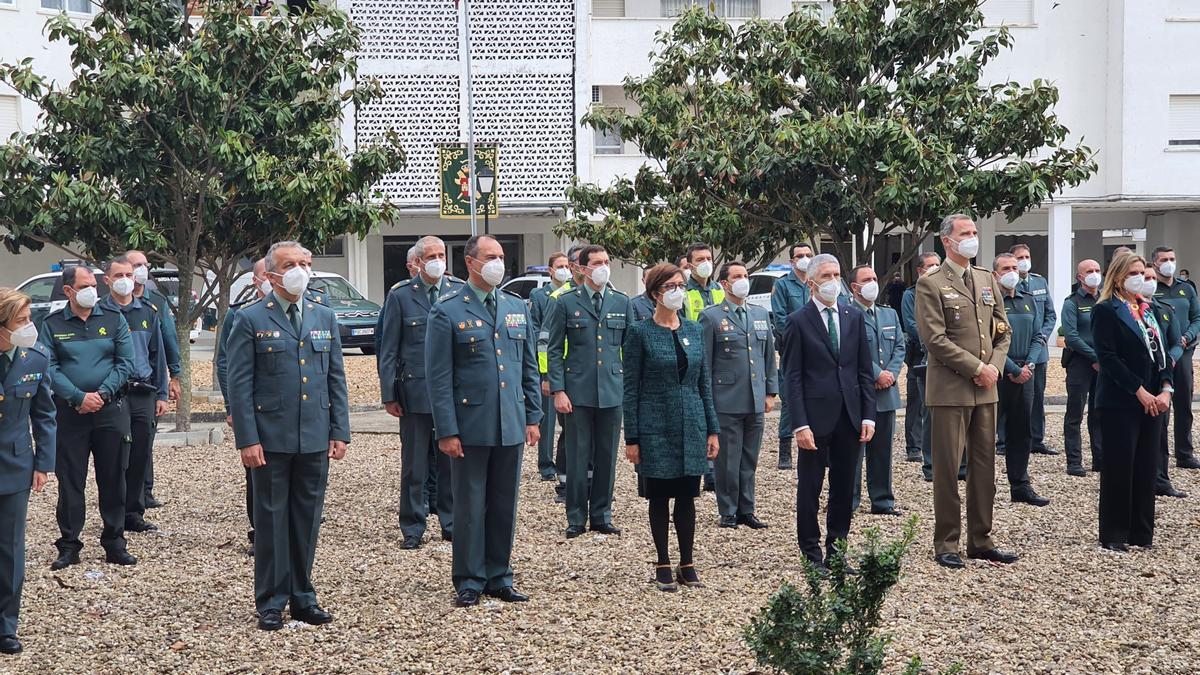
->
[9,403,1200,674]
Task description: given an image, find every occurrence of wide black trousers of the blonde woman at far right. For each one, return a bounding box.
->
[1100,408,1166,545]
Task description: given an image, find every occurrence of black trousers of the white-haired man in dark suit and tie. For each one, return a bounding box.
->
[796,411,860,562]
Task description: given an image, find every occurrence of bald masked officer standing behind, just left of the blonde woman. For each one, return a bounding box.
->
[1062,259,1104,476]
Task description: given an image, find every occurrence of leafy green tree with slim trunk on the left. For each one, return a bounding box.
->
[0,0,404,429]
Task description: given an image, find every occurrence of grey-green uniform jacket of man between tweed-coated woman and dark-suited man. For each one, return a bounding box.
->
[700,300,779,414]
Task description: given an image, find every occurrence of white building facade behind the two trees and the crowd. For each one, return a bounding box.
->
[7,0,1200,300]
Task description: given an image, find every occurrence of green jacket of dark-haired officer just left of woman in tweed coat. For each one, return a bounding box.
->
[546,285,629,408]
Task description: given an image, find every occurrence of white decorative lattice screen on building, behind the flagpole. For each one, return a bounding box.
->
[350,0,576,205]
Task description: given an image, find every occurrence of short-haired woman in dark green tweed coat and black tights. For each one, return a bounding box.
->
[624,263,720,591]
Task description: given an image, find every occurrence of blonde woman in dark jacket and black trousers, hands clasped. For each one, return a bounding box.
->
[1092,253,1178,552]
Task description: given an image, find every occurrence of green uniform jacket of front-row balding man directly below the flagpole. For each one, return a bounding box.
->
[425,283,542,448]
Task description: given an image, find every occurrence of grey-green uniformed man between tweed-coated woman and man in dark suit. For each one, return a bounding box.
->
[700,261,779,530]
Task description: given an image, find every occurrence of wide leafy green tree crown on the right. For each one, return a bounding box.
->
[557,0,1097,271]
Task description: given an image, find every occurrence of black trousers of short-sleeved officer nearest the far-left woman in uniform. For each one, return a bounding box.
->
[54,398,130,554]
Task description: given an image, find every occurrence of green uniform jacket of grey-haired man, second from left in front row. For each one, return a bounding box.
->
[226,292,350,454]
